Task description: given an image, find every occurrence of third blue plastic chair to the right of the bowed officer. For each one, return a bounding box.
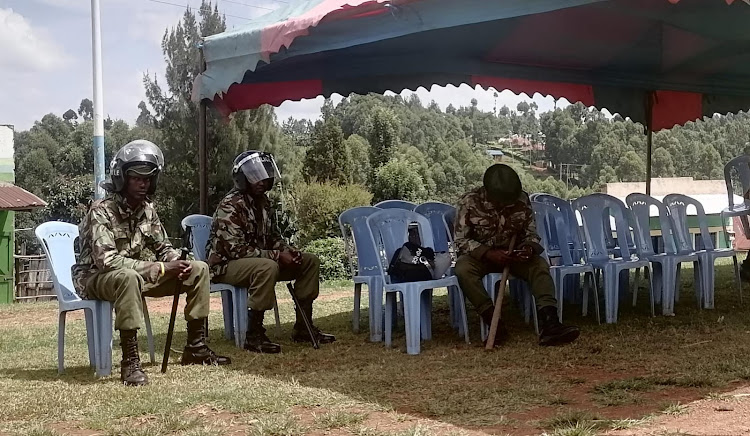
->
[625,193,702,315]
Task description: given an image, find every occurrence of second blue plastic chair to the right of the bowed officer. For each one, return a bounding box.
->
[573,194,654,323]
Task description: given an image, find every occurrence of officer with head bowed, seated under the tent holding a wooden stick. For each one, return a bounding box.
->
[455,164,580,345]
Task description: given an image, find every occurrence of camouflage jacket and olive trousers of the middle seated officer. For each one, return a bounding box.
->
[206,189,320,311]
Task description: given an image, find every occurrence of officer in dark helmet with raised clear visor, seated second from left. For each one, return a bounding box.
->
[206,150,336,353]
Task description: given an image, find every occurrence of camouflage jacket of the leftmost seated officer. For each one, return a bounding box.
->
[72,194,180,298]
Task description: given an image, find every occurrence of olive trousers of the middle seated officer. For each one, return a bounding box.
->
[214,253,320,311]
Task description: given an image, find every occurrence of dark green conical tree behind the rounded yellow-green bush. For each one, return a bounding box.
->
[304,116,352,185]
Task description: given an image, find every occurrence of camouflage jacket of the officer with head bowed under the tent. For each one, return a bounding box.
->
[455,186,542,259]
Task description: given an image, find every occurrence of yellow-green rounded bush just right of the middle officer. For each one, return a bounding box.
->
[293,183,372,245]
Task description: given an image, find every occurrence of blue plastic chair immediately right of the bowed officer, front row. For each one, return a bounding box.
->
[531,202,601,321]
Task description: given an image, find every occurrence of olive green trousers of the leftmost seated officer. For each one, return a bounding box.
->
[86,261,211,330]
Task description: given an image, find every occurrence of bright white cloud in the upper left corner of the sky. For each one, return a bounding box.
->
[0,9,69,74]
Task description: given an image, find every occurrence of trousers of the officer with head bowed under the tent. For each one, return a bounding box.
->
[456,255,557,314]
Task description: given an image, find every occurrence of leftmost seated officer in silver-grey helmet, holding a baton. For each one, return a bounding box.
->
[72,140,230,386]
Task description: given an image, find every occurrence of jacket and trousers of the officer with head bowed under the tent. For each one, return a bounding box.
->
[455,187,557,314]
